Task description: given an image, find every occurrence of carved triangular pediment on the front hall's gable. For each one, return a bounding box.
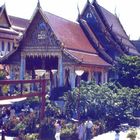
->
[22,12,60,49]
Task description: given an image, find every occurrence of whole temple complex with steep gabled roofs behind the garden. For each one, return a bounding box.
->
[0,0,139,95]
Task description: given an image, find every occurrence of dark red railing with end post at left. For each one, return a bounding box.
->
[0,79,46,119]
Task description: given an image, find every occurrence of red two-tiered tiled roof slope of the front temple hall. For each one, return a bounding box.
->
[44,12,108,66]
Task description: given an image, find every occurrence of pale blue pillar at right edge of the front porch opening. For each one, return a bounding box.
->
[58,56,64,87]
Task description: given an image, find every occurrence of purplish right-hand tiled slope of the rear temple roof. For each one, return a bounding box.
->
[93,1,139,55]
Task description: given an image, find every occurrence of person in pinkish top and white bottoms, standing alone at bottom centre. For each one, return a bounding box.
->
[54,120,61,140]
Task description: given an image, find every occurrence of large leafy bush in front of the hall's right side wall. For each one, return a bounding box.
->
[64,81,140,129]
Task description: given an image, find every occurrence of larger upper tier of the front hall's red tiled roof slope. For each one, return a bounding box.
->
[44,12,97,53]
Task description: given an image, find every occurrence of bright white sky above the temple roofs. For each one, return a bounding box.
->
[0,0,140,40]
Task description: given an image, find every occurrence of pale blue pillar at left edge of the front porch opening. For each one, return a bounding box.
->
[20,55,26,80]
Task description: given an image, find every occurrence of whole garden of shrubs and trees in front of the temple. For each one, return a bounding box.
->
[0,57,140,140]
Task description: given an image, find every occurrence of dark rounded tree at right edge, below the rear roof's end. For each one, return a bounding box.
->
[114,55,140,87]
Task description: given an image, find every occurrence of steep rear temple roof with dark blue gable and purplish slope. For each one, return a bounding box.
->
[78,0,139,63]
